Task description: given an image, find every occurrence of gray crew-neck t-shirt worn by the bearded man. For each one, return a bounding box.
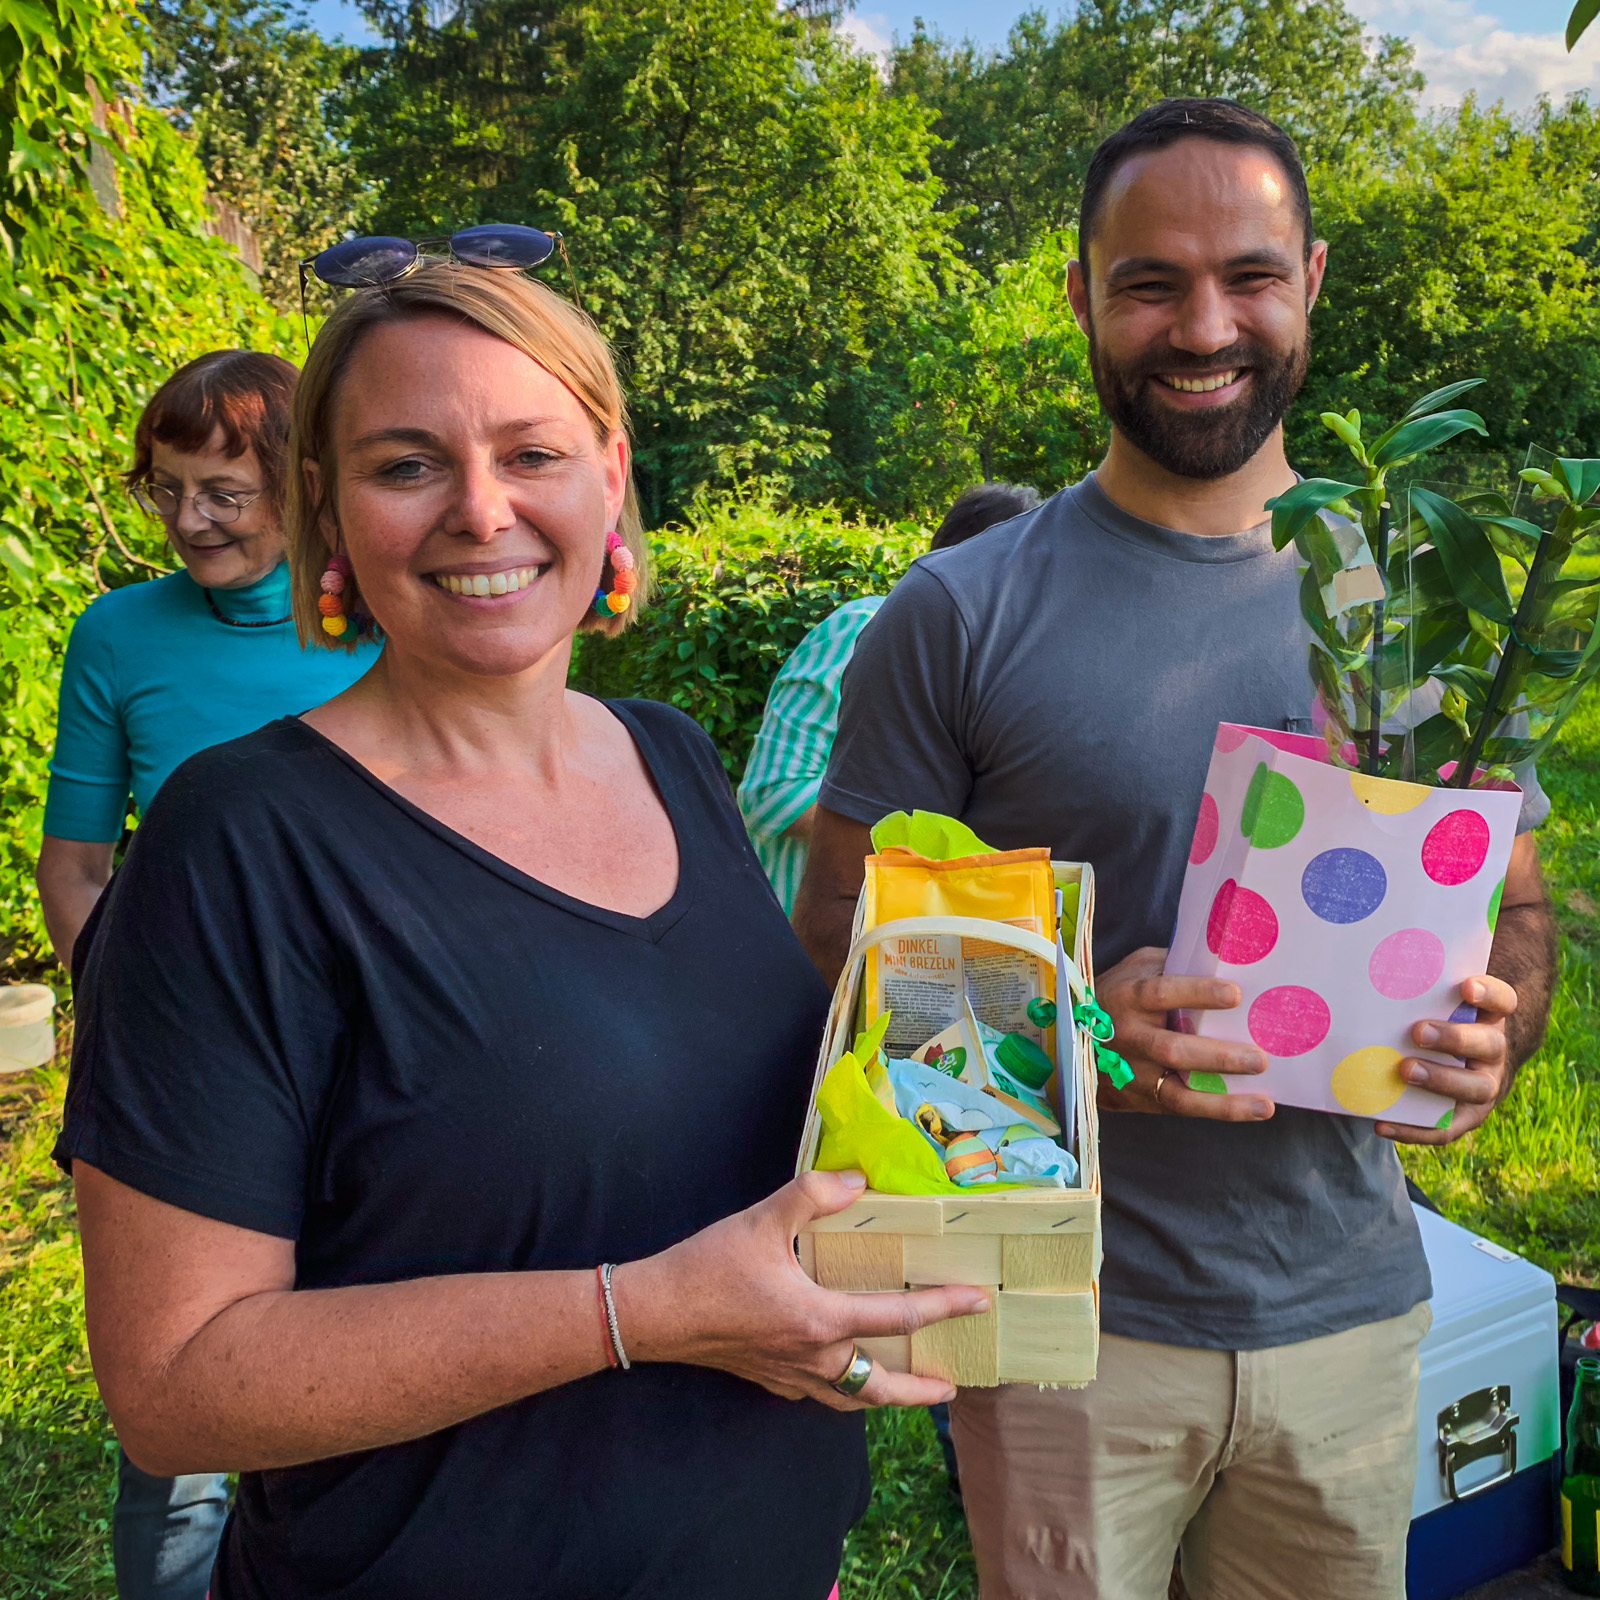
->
[821,475,1430,1349]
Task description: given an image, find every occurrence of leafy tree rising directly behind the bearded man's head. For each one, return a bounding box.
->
[893,0,1422,272]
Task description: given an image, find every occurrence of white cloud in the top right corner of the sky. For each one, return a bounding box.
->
[1354,0,1600,110]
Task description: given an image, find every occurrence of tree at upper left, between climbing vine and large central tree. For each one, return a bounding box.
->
[142,0,368,310]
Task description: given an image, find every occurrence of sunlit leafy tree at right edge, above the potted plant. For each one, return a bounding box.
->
[1290,99,1600,474]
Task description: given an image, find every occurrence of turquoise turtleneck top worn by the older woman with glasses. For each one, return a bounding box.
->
[45,562,379,843]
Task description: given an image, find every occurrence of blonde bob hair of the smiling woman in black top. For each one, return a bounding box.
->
[283,261,650,650]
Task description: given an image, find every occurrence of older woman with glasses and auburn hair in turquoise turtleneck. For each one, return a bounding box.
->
[37,350,378,1600]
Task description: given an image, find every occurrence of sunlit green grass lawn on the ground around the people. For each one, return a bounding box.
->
[0,696,1600,1600]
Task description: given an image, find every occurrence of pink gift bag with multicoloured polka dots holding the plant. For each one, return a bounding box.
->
[1166,723,1522,1126]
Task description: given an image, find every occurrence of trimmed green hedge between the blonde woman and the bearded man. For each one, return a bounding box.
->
[571,486,930,782]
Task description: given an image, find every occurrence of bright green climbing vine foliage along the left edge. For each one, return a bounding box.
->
[0,0,294,968]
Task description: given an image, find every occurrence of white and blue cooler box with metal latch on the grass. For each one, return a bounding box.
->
[1406,1206,1562,1600]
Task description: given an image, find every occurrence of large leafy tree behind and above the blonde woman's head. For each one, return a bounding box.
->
[352,0,957,523]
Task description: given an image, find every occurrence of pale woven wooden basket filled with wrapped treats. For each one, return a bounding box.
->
[798,813,1126,1386]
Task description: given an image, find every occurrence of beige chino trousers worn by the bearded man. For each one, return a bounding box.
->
[950,1302,1432,1600]
